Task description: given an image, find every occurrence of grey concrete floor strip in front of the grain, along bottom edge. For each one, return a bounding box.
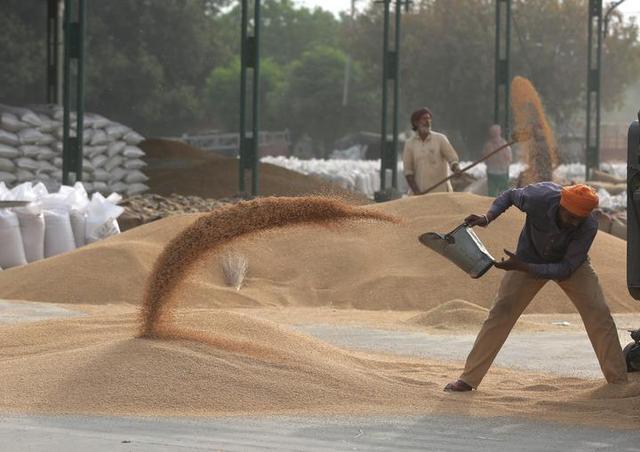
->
[0,416,640,452]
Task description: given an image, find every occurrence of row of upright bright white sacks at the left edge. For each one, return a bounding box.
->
[0,182,124,269]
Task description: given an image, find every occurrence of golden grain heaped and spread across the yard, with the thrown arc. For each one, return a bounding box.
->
[0,193,640,429]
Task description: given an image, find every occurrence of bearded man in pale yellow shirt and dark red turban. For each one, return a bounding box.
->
[402,107,460,195]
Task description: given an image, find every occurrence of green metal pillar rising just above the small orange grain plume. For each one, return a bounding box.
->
[493,0,511,136]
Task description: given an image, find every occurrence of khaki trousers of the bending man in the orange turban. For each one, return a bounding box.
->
[460,261,627,388]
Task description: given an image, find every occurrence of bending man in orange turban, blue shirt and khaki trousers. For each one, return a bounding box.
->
[445,182,627,391]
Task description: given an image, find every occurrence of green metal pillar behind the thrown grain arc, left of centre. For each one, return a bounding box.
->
[238,0,260,196]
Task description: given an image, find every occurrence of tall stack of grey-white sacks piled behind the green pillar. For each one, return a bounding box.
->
[0,104,149,196]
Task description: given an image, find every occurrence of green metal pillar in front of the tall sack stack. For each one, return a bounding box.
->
[62,0,86,185]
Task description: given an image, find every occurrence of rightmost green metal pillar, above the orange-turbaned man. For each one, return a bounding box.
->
[585,0,602,179]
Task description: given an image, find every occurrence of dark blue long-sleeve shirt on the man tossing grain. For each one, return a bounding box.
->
[489,182,598,280]
